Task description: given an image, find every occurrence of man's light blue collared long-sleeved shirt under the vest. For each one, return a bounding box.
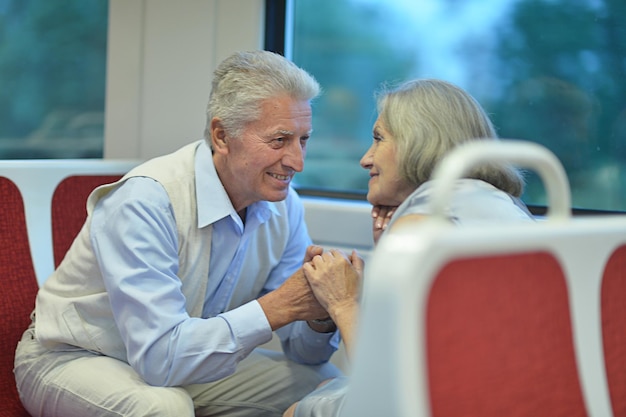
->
[91,145,338,385]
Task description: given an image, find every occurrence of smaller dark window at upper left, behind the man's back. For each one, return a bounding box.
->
[0,0,108,159]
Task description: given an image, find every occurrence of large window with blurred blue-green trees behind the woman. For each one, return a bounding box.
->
[285,0,626,211]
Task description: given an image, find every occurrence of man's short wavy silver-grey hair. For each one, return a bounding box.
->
[204,51,321,145]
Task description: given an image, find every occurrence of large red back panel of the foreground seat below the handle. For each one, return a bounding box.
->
[426,253,586,417]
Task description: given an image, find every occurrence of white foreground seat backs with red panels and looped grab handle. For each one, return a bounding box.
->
[341,144,626,417]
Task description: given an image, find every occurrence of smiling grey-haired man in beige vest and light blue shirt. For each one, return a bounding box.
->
[15,51,338,417]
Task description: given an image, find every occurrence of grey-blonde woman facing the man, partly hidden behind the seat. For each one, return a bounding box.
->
[285,79,533,417]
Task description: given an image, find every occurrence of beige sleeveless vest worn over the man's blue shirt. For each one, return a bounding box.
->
[35,142,289,361]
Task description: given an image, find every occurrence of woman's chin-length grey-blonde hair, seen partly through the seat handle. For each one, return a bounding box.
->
[377,79,524,197]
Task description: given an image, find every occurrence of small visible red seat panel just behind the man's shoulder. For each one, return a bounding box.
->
[51,174,122,268]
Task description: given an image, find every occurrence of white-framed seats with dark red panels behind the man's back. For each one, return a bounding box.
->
[0,160,139,417]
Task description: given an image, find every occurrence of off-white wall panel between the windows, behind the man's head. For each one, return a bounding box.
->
[105,0,264,159]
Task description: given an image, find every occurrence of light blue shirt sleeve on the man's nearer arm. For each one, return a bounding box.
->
[91,177,271,386]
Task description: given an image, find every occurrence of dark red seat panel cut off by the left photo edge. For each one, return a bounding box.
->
[0,177,38,416]
